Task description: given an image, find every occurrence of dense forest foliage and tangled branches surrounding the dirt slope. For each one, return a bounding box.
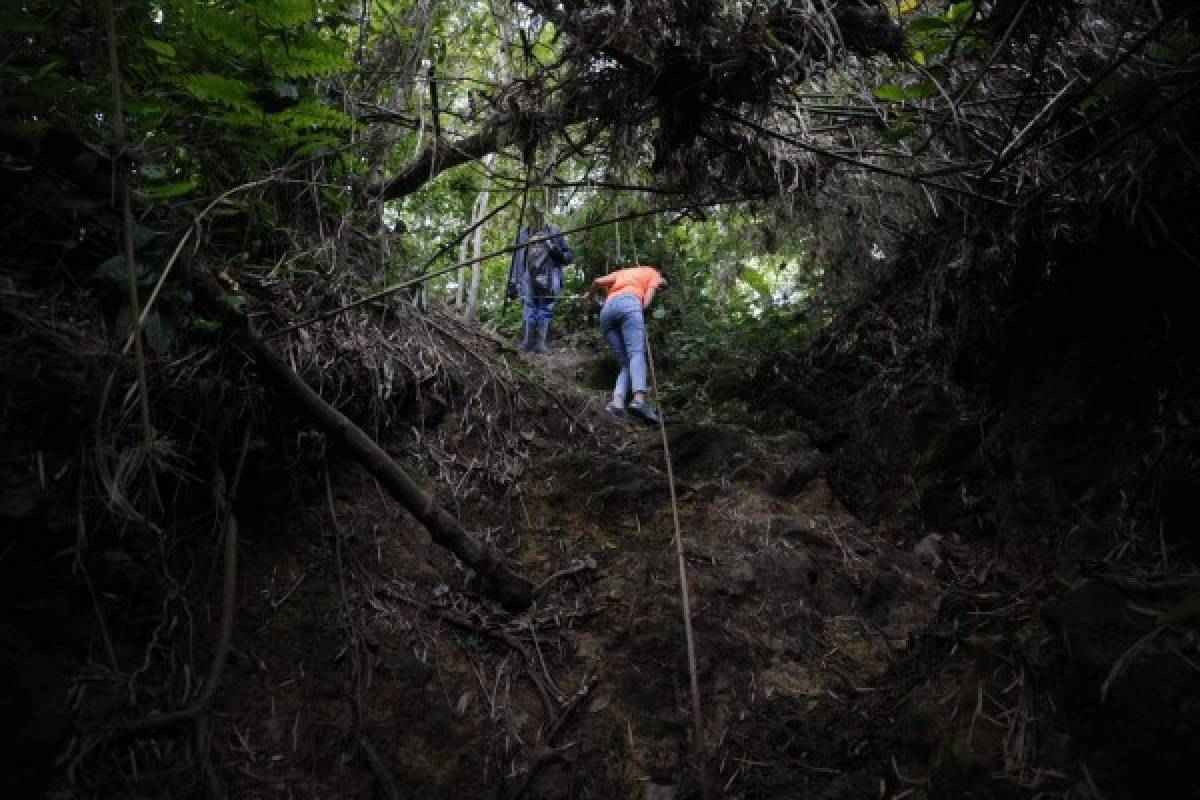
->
[0,0,1200,794]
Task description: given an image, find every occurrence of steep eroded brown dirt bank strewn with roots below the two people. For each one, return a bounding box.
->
[5,302,1200,800]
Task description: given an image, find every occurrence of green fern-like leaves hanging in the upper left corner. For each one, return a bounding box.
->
[0,0,365,351]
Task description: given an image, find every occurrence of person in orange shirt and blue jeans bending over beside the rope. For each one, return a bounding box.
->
[587,266,667,422]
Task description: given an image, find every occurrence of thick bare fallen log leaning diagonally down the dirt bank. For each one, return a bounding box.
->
[193,270,533,612]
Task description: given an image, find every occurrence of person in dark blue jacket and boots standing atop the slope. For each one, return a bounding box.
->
[508,206,575,353]
